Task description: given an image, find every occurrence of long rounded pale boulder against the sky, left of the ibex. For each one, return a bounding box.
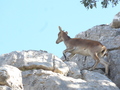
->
[0,50,69,75]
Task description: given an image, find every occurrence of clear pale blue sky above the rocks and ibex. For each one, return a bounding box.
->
[0,0,120,57]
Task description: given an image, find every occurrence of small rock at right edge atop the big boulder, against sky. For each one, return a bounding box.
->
[110,12,120,28]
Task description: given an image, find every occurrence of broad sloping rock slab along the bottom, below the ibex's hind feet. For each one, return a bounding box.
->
[23,70,119,90]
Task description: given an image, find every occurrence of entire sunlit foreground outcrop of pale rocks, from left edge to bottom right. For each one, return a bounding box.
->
[0,50,119,90]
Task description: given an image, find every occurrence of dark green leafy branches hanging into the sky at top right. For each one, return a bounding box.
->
[80,0,120,9]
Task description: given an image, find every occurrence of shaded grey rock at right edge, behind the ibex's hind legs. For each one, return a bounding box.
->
[109,50,120,88]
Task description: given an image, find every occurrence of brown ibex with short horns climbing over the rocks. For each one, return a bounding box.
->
[56,26,109,74]
